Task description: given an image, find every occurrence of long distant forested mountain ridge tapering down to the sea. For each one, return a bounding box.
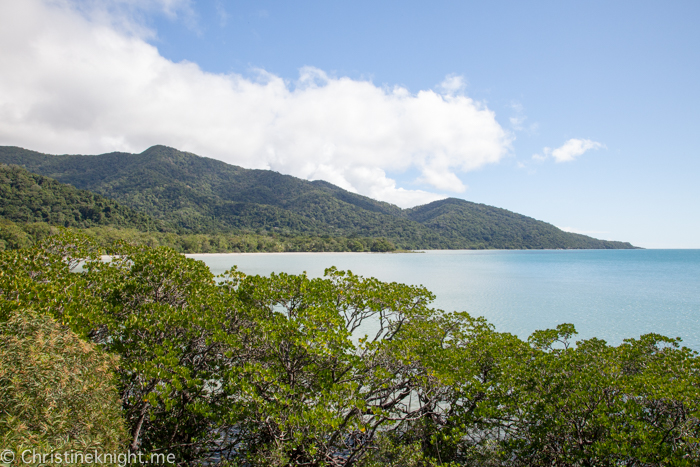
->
[0,146,633,249]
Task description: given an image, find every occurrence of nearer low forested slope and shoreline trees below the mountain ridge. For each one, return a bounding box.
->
[0,164,396,253]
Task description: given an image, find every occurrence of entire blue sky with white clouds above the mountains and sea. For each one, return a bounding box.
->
[0,0,700,248]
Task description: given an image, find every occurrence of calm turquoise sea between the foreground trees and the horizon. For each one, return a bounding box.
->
[188,250,700,350]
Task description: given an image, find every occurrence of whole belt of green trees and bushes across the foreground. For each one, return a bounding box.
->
[0,236,700,467]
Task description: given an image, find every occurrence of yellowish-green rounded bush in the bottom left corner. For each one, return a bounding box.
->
[0,309,126,453]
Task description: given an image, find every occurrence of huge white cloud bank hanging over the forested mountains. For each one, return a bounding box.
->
[0,0,516,206]
